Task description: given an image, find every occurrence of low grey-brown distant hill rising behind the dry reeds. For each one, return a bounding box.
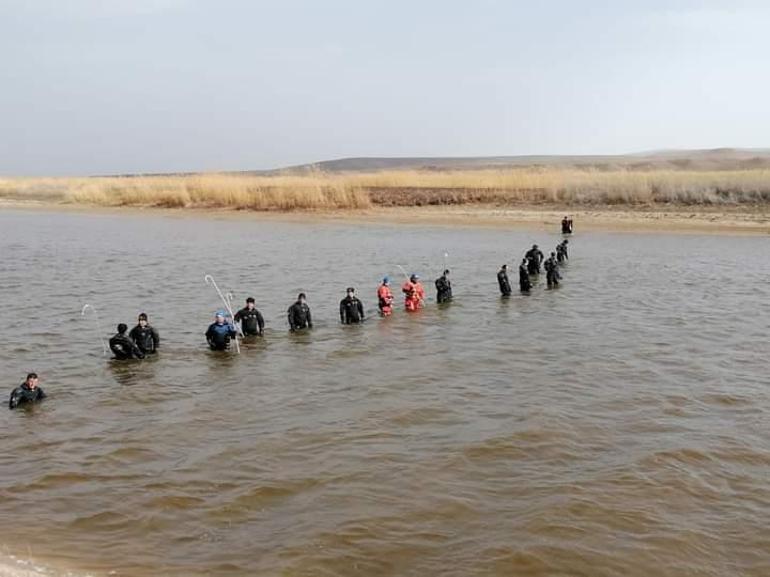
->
[254,148,770,174]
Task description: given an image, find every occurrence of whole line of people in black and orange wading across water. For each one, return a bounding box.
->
[8,216,573,409]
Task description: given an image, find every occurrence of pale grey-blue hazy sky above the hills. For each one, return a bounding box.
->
[0,0,770,176]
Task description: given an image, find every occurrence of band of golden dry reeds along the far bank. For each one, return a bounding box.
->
[0,168,770,211]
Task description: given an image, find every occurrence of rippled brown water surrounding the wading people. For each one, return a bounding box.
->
[0,212,770,577]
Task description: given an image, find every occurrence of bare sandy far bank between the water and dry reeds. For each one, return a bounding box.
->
[0,199,770,235]
